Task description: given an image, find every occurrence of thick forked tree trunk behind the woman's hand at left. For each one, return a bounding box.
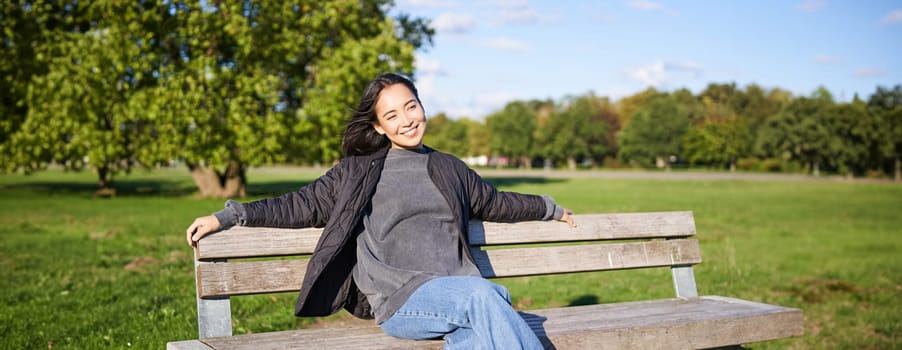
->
[188,161,247,198]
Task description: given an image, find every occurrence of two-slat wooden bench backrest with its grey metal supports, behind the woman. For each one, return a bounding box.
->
[194,211,701,338]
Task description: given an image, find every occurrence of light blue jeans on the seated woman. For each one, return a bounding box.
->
[380,276,543,350]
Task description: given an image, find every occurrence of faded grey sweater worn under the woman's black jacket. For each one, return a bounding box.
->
[354,149,480,323]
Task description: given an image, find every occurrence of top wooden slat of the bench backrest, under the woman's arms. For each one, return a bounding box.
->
[197,211,695,259]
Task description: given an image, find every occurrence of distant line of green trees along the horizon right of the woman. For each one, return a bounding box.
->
[426,83,902,180]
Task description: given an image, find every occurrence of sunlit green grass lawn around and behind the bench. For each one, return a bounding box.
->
[0,168,902,349]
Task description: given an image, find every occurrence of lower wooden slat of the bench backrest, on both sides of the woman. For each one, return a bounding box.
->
[197,239,701,297]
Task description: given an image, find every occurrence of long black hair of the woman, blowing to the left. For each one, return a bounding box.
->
[341,73,420,156]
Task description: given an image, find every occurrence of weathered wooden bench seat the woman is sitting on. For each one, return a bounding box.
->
[192,296,803,350]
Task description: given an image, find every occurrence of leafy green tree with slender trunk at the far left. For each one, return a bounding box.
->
[0,1,159,192]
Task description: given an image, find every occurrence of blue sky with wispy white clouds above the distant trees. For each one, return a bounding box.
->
[394,0,902,119]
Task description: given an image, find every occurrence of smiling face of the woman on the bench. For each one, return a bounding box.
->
[373,84,426,149]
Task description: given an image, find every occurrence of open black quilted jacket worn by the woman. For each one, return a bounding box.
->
[244,149,547,318]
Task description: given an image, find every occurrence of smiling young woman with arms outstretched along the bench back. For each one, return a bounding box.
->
[187,74,573,349]
